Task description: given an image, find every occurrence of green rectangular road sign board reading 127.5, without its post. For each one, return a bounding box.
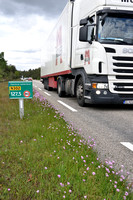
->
[8,81,33,99]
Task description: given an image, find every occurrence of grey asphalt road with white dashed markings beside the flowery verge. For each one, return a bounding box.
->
[33,81,133,182]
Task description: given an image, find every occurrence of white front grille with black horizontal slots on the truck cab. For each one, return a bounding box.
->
[109,56,133,94]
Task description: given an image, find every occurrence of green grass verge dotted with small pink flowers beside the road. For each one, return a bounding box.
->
[0,83,133,200]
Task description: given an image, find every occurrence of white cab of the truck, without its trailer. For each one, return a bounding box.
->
[74,0,133,104]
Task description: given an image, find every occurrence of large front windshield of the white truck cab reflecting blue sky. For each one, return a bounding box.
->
[98,13,133,45]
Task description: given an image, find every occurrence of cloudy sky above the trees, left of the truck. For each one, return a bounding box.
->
[0,0,68,71]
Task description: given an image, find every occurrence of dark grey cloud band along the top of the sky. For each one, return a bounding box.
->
[0,0,68,17]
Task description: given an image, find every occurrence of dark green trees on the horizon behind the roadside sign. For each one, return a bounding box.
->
[0,52,40,81]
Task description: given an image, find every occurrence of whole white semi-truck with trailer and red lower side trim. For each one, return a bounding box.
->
[41,0,133,106]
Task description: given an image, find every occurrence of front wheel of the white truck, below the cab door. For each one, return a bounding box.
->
[76,78,85,107]
